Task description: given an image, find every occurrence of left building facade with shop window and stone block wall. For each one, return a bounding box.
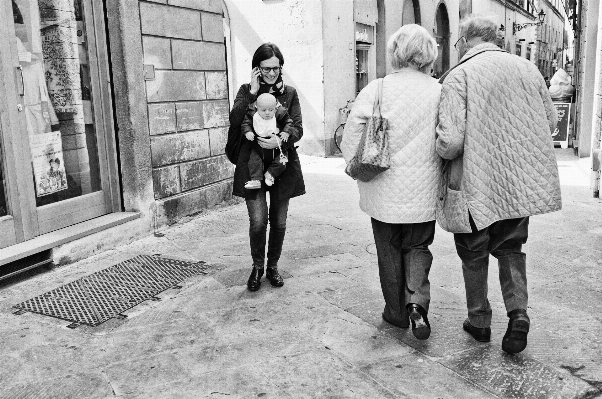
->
[0,0,233,268]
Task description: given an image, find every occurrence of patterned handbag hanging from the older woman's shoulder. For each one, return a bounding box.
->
[345,79,391,182]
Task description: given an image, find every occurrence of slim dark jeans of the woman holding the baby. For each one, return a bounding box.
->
[246,187,289,268]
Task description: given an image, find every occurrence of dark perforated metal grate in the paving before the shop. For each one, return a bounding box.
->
[14,255,207,326]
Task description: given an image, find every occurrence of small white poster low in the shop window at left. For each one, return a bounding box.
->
[29,132,67,197]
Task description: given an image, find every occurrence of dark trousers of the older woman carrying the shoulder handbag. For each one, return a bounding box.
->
[372,219,435,327]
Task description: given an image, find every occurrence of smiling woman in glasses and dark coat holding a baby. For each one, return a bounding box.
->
[230,43,305,291]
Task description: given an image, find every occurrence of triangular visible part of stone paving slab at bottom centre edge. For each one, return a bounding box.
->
[124,348,395,399]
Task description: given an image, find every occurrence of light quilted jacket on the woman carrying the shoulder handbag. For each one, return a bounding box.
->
[341,68,441,223]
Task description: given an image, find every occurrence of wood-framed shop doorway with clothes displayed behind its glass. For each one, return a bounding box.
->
[0,0,120,248]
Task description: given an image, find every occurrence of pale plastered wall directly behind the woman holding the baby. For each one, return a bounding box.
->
[225,0,324,155]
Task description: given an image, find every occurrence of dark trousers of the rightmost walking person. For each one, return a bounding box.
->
[454,217,529,328]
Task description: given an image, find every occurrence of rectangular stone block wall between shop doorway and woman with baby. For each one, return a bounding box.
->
[139,0,234,222]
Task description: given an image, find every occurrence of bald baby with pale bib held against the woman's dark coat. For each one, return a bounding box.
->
[241,93,293,190]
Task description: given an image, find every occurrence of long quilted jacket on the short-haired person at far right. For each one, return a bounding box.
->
[437,43,562,232]
